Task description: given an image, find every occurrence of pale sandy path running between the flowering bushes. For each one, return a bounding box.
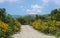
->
[12,25,55,38]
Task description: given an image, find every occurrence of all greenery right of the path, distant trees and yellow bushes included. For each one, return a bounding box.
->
[17,9,60,37]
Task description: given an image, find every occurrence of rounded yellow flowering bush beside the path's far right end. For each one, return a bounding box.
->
[32,20,48,32]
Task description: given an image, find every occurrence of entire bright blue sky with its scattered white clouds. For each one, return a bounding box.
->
[0,0,60,15]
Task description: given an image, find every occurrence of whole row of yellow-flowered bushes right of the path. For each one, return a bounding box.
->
[32,20,60,34]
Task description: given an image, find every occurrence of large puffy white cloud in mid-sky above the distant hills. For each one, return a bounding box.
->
[26,4,43,14]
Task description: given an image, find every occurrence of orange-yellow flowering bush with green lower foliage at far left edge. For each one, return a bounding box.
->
[0,21,10,38]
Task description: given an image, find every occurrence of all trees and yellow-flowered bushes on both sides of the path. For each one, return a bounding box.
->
[0,8,60,38]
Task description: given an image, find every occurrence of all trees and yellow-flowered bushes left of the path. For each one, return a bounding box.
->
[0,8,21,38]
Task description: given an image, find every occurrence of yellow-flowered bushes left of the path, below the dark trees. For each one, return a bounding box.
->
[0,20,21,38]
